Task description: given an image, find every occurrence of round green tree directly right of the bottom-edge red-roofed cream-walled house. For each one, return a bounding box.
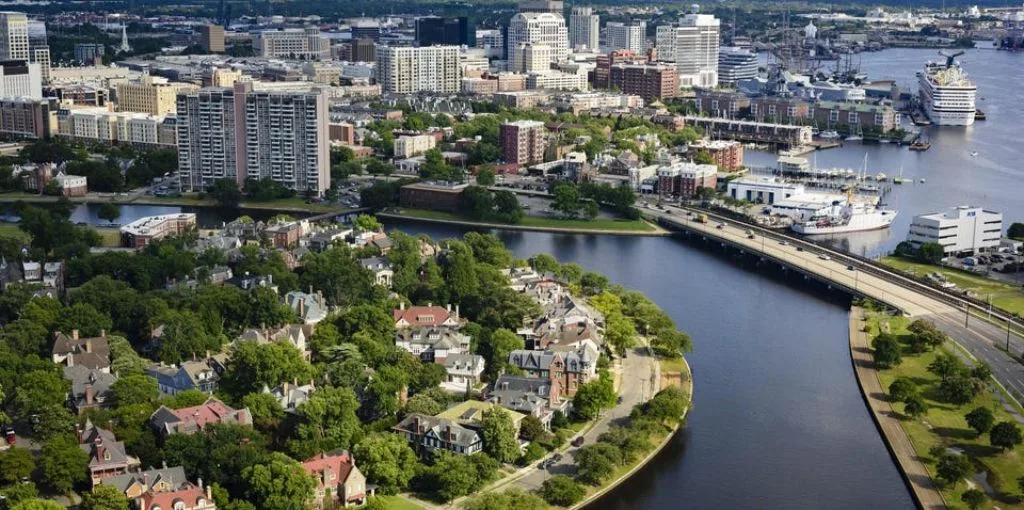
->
[352,433,417,494]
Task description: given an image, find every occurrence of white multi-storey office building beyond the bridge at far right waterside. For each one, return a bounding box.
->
[907,206,1002,254]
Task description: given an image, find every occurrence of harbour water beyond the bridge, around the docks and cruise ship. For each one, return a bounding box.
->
[744,48,1024,256]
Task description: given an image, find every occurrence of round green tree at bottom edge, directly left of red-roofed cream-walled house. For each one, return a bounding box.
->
[242,453,316,510]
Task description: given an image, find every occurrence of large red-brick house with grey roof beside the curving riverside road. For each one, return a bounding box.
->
[509,346,599,398]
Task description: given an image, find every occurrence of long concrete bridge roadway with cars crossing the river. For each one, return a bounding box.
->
[644,206,1024,399]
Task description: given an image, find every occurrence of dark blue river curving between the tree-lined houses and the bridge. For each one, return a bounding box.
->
[387,222,913,510]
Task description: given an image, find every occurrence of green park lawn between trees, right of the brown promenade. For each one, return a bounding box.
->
[868,314,1024,508]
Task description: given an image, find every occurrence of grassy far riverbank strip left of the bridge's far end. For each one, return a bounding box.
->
[377,209,672,237]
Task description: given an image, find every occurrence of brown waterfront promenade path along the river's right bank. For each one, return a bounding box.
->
[850,306,946,510]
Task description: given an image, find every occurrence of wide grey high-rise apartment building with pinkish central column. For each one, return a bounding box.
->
[177,82,330,194]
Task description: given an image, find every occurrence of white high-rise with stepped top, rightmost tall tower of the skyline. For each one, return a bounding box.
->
[656,14,721,88]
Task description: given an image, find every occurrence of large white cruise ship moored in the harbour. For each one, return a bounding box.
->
[918,51,978,126]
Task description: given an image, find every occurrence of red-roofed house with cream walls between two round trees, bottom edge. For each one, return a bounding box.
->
[302,451,374,510]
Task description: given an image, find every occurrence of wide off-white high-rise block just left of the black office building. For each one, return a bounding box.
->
[377,46,462,94]
